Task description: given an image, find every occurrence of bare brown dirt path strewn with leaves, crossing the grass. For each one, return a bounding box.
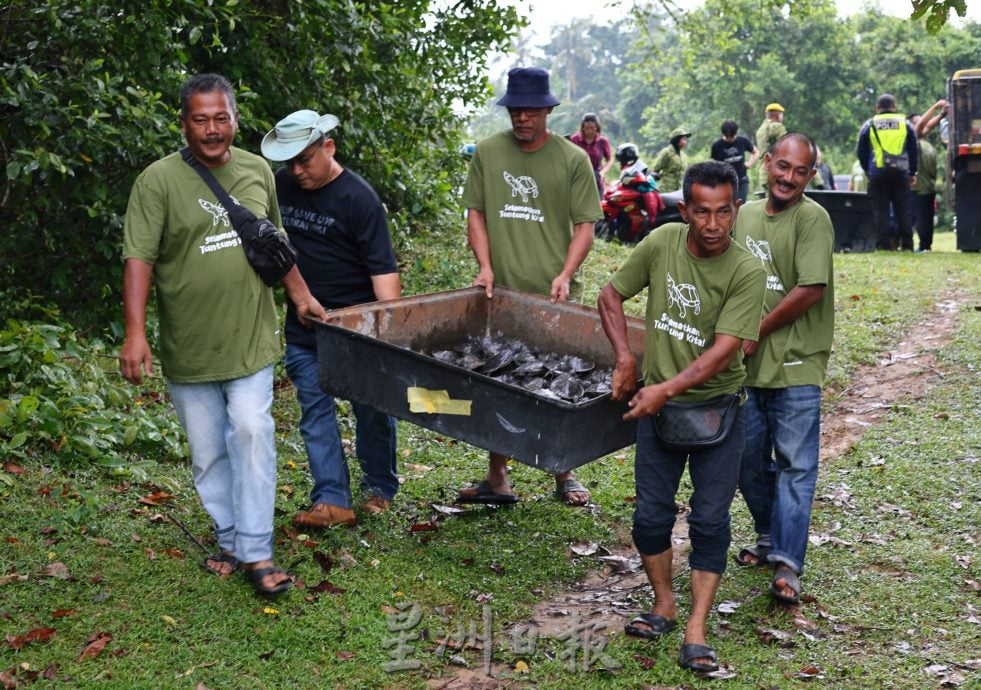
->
[430,291,962,690]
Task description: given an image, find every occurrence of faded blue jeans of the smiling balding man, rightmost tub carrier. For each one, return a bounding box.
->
[739,386,821,573]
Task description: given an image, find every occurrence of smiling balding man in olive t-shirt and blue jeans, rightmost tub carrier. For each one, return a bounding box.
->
[733,132,834,603]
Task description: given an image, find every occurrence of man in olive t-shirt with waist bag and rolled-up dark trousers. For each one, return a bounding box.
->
[599,161,766,671]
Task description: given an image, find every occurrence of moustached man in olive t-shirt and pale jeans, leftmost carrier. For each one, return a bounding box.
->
[119,74,327,596]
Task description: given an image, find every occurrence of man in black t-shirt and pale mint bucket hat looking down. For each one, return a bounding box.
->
[262,110,402,528]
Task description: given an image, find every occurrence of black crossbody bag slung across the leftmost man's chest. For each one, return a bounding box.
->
[181,146,296,286]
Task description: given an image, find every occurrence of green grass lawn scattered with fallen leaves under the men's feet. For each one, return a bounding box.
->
[0,233,981,689]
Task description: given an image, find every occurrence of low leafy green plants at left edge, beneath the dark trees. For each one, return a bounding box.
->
[0,304,186,477]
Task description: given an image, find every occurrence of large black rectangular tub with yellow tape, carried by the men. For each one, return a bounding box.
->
[316,288,644,472]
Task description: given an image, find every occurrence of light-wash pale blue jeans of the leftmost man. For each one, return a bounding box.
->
[167,365,276,563]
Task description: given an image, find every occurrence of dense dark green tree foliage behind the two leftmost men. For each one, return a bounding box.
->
[0,0,518,321]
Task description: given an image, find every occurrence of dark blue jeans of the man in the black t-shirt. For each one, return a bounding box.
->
[286,345,399,508]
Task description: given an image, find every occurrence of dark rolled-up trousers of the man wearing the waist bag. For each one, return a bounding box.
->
[633,405,745,575]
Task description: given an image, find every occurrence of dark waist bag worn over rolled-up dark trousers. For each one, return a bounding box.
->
[654,389,746,450]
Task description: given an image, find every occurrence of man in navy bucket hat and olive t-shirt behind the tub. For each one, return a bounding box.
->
[458,67,603,505]
